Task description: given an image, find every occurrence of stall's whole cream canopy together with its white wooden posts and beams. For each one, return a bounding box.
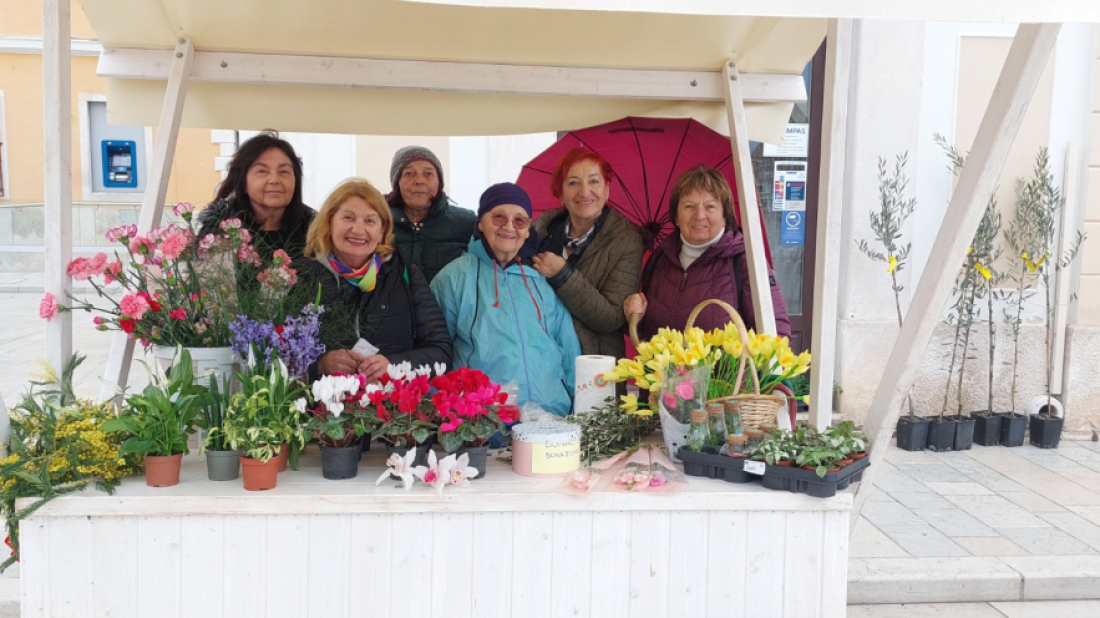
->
[43,0,1082,534]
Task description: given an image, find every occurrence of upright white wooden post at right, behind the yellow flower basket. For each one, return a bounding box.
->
[810,20,851,429]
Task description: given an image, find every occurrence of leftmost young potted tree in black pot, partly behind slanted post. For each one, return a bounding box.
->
[857,153,928,451]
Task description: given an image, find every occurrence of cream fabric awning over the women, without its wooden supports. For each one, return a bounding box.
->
[81,0,826,142]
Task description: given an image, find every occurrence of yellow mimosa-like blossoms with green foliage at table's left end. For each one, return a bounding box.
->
[0,354,142,572]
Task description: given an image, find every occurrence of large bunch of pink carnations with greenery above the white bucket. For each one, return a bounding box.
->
[39,203,297,347]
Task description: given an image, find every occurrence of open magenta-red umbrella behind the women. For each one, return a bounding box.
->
[516,117,771,263]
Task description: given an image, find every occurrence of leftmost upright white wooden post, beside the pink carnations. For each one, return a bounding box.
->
[42,0,73,374]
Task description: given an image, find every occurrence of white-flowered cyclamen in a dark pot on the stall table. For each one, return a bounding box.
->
[295,375,377,479]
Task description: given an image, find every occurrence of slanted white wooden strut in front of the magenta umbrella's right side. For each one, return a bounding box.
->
[722,60,782,334]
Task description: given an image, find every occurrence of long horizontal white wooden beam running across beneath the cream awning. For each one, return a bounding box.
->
[96,48,806,102]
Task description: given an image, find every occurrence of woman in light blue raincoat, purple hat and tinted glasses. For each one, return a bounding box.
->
[431,183,581,416]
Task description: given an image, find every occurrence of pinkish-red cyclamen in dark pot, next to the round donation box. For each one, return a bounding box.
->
[429,367,519,453]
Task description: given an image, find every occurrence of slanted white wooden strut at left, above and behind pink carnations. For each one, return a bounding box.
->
[99,36,195,401]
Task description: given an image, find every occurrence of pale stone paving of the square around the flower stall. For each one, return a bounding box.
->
[0,285,1100,607]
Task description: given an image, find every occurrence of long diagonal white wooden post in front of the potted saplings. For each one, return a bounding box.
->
[851,23,1062,529]
